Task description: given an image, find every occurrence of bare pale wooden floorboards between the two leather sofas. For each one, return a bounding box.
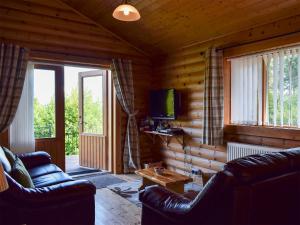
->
[95,188,141,225]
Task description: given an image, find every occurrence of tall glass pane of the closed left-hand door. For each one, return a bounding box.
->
[34,69,56,138]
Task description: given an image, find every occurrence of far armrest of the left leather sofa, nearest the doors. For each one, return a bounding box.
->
[17,151,51,169]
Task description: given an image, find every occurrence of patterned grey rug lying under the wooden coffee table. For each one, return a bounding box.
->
[107,179,202,207]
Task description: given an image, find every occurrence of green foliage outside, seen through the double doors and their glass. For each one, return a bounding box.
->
[34,89,103,155]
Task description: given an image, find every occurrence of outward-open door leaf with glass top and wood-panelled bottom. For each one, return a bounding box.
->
[78,70,108,170]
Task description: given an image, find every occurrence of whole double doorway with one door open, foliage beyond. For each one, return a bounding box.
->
[34,63,118,173]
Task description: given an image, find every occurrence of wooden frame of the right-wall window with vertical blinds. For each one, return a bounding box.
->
[223,45,300,148]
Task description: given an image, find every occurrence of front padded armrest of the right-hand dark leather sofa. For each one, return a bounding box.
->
[139,186,192,218]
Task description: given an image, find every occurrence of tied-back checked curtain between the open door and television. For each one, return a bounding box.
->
[111,59,141,173]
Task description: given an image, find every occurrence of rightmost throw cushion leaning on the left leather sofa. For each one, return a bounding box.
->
[11,157,34,188]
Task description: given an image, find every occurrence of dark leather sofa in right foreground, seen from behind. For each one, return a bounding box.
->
[139,148,300,225]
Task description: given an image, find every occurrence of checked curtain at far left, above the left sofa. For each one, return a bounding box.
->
[0,43,28,133]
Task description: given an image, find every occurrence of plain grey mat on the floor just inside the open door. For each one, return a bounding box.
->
[73,173,126,189]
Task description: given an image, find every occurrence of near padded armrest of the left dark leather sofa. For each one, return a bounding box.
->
[8,180,96,207]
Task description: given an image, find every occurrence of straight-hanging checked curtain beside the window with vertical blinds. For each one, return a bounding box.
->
[203,48,223,145]
